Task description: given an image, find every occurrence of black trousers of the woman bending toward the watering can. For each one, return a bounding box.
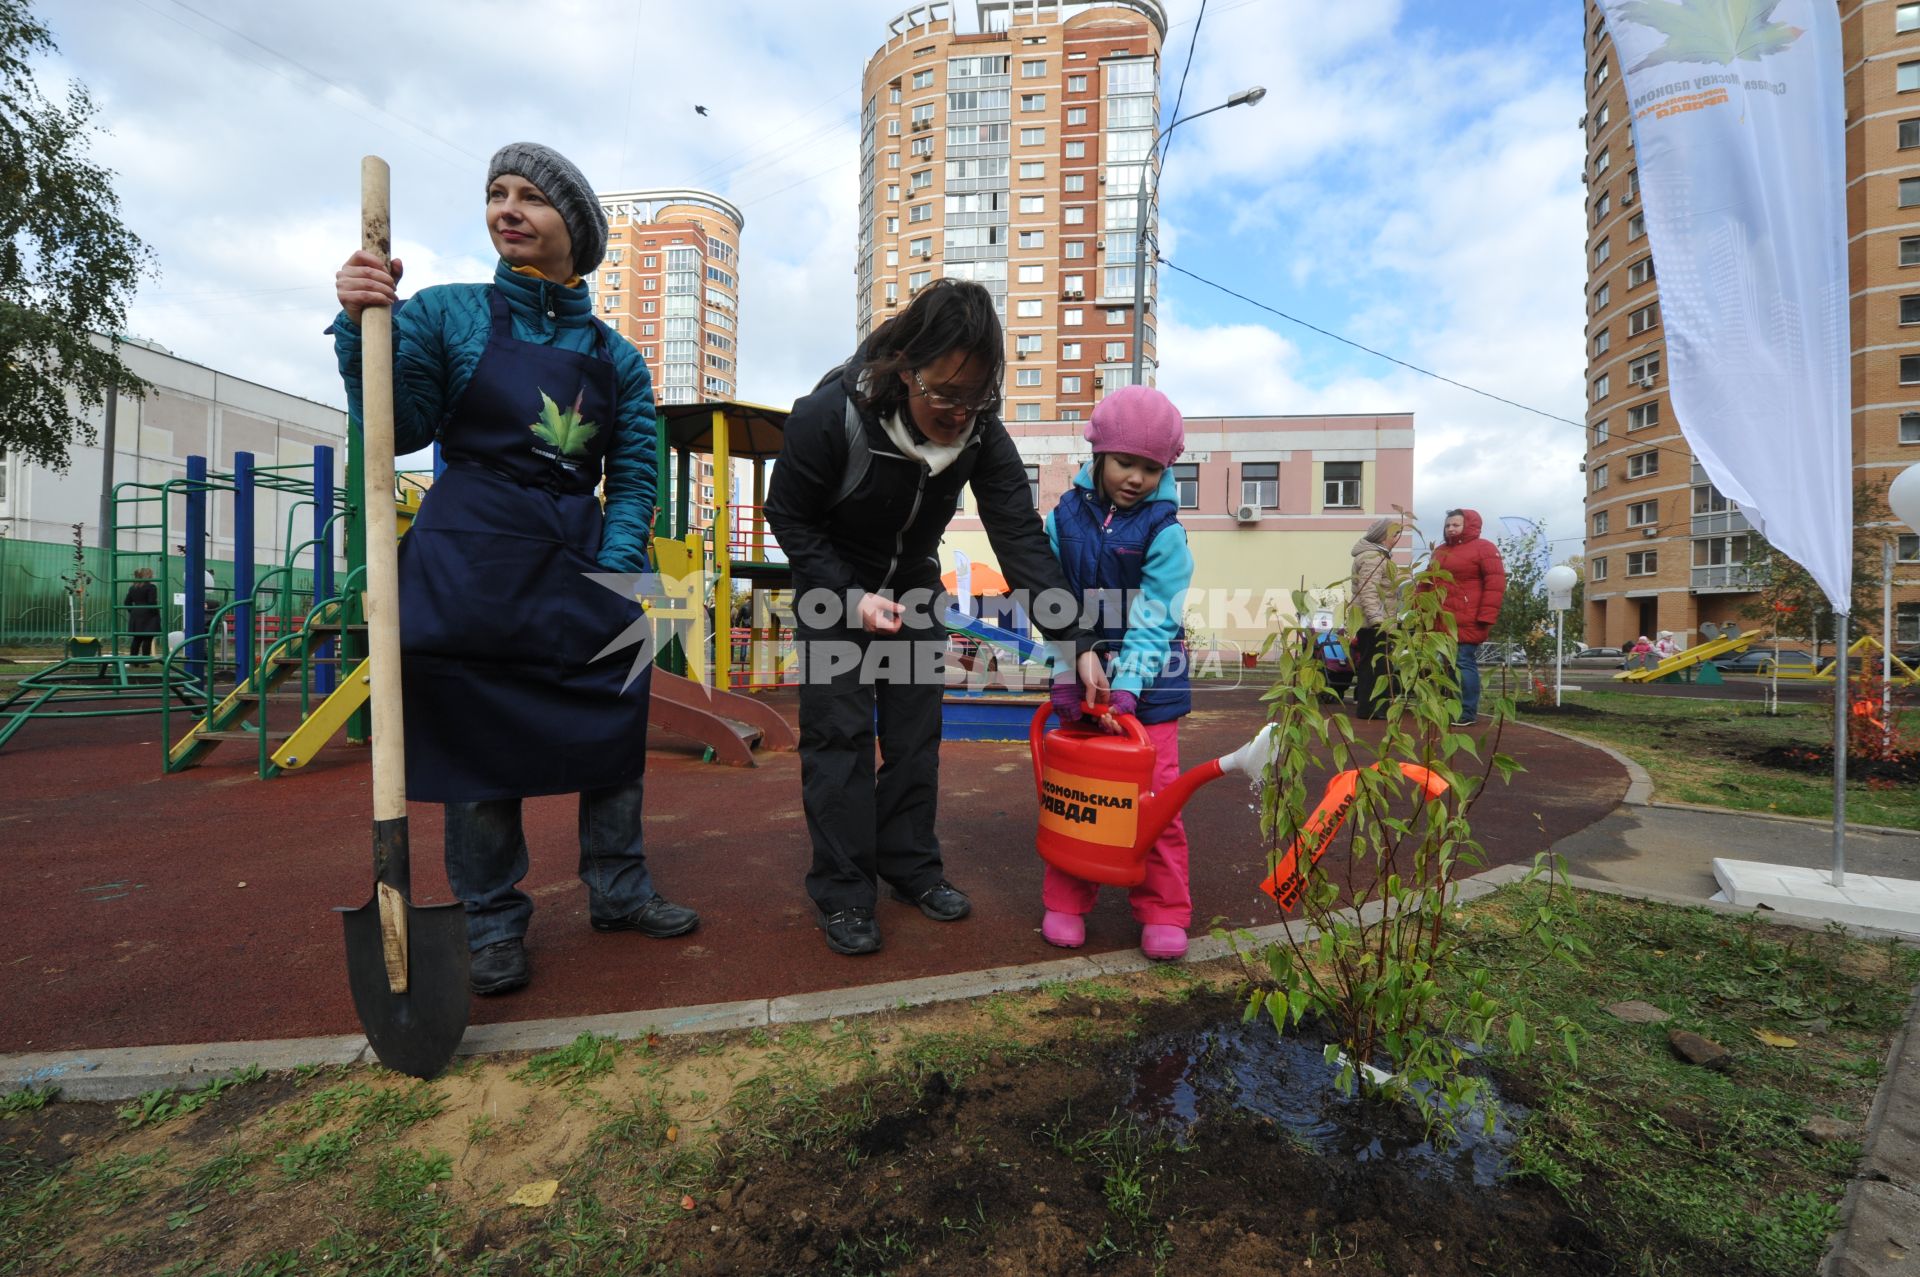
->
[799,622,947,914]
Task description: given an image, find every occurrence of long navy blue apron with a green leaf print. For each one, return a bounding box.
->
[399,288,653,803]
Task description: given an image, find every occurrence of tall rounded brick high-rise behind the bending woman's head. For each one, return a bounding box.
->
[854,0,1167,422]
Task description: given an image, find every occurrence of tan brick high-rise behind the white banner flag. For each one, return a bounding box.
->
[1582,0,1920,645]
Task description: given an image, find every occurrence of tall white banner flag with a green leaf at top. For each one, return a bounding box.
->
[1599,0,1853,611]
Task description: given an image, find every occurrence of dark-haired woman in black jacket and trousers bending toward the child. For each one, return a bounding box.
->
[766,278,1106,954]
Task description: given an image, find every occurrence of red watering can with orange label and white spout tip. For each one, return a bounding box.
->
[1029,705,1275,887]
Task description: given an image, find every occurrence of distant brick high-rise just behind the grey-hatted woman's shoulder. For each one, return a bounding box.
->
[588,190,747,528]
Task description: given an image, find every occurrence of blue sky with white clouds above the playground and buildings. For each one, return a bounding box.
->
[35,0,1584,555]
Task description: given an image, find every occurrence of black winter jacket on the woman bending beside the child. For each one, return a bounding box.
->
[766,355,1094,651]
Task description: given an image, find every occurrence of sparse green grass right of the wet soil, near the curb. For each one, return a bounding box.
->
[1461,887,1920,1277]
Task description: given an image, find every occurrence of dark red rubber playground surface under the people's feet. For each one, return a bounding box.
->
[0,689,1626,1052]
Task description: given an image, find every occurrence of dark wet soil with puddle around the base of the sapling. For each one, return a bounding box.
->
[649,995,1643,1277]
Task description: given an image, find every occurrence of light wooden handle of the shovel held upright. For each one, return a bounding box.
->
[361,156,407,825]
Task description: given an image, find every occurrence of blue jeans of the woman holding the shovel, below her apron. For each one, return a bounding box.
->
[447,778,653,949]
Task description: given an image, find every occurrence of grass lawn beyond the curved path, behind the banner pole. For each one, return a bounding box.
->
[1519,689,1920,830]
